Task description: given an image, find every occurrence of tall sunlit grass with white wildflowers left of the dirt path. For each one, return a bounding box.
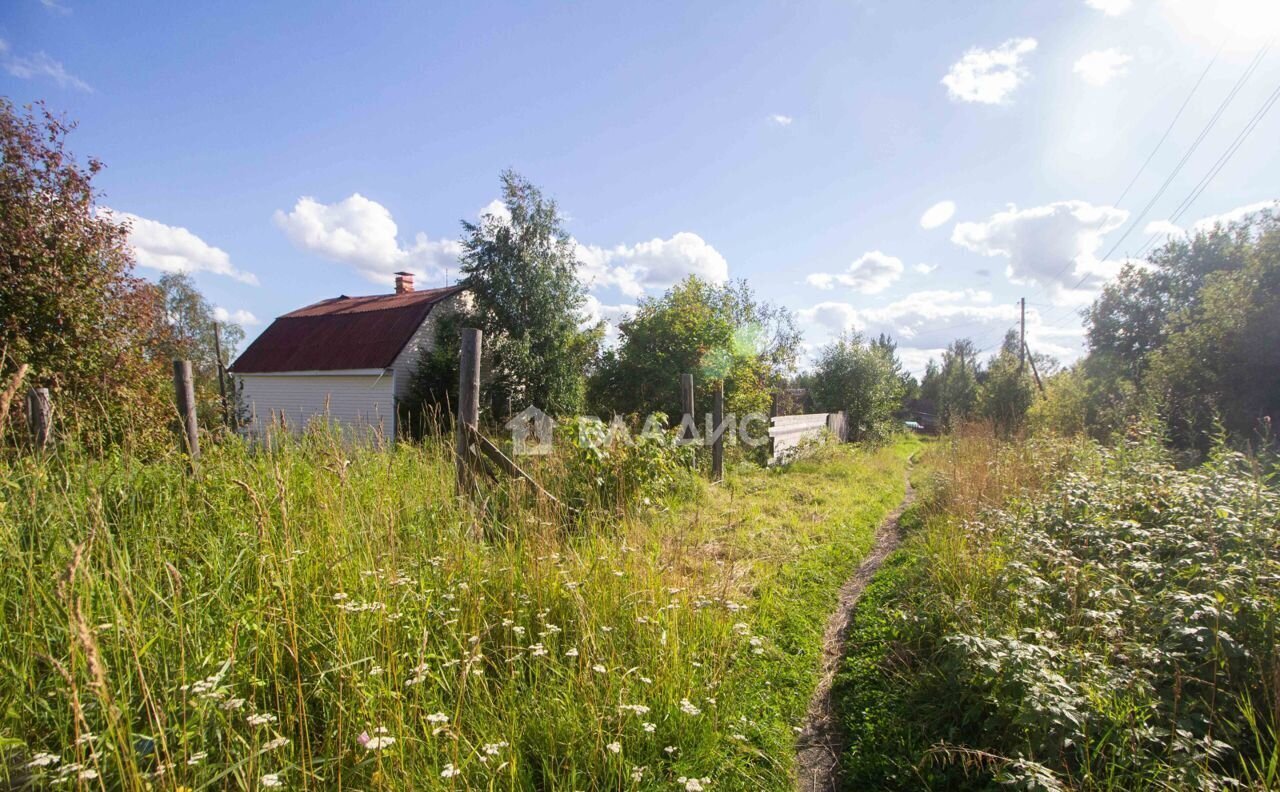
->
[0,424,909,789]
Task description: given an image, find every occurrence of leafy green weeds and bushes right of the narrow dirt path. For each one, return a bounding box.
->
[837,441,1280,792]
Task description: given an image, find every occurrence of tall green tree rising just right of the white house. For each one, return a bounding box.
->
[462,170,603,416]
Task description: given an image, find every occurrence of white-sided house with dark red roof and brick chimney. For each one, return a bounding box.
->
[228,273,465,438]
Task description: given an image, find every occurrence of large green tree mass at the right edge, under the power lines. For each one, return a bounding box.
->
[1078,212,1280,458]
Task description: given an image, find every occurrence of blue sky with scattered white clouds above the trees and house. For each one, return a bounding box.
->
[0,0,1280,371]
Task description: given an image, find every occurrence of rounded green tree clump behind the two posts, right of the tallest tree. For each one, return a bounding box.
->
[590,275,800,427]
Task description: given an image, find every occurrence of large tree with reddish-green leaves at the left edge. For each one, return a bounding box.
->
[0,99,173,445]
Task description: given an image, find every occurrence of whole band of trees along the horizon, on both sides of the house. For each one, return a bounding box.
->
[10,99,1280,455]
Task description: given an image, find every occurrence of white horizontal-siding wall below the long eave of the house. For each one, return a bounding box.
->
[237,370,396,439]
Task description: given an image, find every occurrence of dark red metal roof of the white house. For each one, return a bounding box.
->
[229,287,463,374]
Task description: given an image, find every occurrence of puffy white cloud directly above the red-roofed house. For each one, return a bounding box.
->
[275,192,462,284]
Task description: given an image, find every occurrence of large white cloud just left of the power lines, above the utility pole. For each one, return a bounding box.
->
[951,201,1129,301]
